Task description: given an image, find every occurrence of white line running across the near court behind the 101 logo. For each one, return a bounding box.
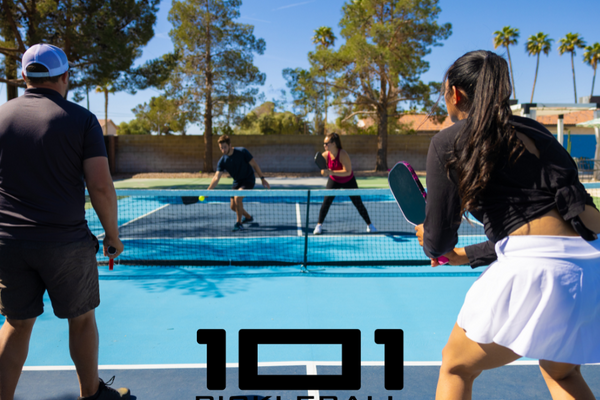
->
[23,360,600,372]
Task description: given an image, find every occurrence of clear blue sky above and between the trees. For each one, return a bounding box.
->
[0,0,600,133]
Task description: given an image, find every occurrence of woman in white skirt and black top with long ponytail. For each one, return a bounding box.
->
[416,51,600,400]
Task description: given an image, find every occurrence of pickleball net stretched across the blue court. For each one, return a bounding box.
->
[86,189,485,267]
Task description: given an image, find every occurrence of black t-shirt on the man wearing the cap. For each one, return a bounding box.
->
[0,88,106,242]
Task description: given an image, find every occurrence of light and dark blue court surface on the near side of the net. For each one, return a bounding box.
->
[8,265,600,400]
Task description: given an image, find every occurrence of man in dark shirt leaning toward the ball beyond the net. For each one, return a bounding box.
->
[208,135,271,232]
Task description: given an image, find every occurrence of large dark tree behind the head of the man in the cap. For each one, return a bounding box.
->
[0,0,160,99]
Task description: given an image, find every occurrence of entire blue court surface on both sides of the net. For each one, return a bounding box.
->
[9,183,600,400]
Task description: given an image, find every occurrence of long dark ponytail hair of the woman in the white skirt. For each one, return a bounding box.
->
[444,50,524,213]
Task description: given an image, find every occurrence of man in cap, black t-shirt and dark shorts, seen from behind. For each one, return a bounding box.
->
[0,44,130,400]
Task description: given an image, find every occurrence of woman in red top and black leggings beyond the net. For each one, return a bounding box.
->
[313,133,377,235]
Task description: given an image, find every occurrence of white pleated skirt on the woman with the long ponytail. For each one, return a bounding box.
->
[457,236,600,364]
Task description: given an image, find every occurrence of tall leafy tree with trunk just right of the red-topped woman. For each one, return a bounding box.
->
[313,0,451,171]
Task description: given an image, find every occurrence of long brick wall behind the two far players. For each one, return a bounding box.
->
[115,132,434,173]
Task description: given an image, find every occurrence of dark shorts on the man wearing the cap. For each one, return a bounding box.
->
[0,238,100,320]
